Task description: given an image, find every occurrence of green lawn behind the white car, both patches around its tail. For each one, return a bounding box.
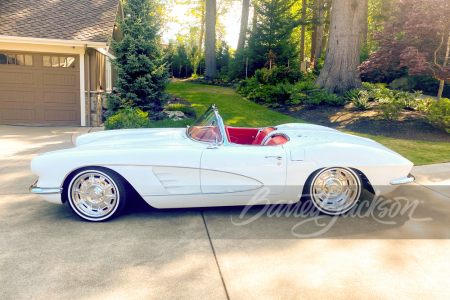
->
[167,82,450,165]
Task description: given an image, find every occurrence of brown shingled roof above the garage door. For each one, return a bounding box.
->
[0,0,119,42]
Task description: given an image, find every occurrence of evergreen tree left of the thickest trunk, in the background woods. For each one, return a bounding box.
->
[248,0,300,71]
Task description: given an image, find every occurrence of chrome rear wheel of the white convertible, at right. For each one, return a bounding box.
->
[310,168,361,215]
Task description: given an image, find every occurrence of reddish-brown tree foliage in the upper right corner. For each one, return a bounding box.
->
[360,0,450,82]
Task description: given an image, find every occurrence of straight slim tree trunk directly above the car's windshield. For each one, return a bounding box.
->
[205,0,217,78]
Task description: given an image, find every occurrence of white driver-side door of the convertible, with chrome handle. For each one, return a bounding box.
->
[200,145,287,197]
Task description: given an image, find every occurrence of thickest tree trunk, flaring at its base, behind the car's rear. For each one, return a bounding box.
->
[314,0,366,95]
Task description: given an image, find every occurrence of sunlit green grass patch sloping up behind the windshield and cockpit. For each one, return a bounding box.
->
[167,82,303,127]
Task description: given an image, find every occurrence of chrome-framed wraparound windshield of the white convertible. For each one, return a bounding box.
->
[187,106,222,143]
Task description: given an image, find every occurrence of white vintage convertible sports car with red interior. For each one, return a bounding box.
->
[30,105,414,221]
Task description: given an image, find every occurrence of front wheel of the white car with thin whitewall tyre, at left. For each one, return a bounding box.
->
[67,168,126,222]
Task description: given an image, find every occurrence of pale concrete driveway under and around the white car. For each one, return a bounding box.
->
[0,125,450,299]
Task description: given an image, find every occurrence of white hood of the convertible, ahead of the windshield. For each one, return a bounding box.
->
[76,128,188,147]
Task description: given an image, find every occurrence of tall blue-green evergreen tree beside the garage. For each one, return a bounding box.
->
[108,0,169,120]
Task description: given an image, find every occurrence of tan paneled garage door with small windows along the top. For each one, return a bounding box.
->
[0,50,81,125]
